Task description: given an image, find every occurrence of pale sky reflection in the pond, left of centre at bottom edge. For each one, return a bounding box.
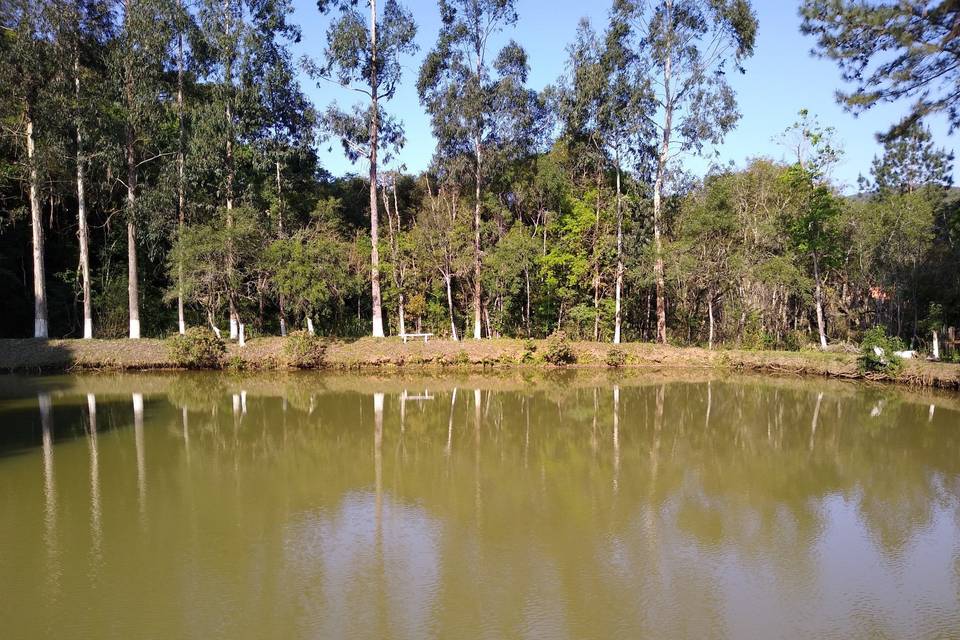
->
[284,492,441,638]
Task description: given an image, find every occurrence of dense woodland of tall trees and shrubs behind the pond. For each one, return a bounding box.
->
[0,0,960,349]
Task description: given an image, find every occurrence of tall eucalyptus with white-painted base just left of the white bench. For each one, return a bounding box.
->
[317,0,417,338]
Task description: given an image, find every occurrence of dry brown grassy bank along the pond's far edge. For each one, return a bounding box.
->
[0,338,960,390]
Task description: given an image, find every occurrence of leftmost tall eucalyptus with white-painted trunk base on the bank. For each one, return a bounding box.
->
[0,0,53,338]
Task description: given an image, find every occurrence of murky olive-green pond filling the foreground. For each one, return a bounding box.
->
[0,370,960,640]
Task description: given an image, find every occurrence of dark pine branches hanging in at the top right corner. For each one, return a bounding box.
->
[800,0,960,137]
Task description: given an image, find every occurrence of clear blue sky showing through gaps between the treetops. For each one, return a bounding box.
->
[294,0,960,192]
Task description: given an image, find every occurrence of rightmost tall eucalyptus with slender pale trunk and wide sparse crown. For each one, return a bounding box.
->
[612,0,757,343]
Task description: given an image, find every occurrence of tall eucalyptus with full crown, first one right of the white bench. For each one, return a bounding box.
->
[417,0,534,339]
